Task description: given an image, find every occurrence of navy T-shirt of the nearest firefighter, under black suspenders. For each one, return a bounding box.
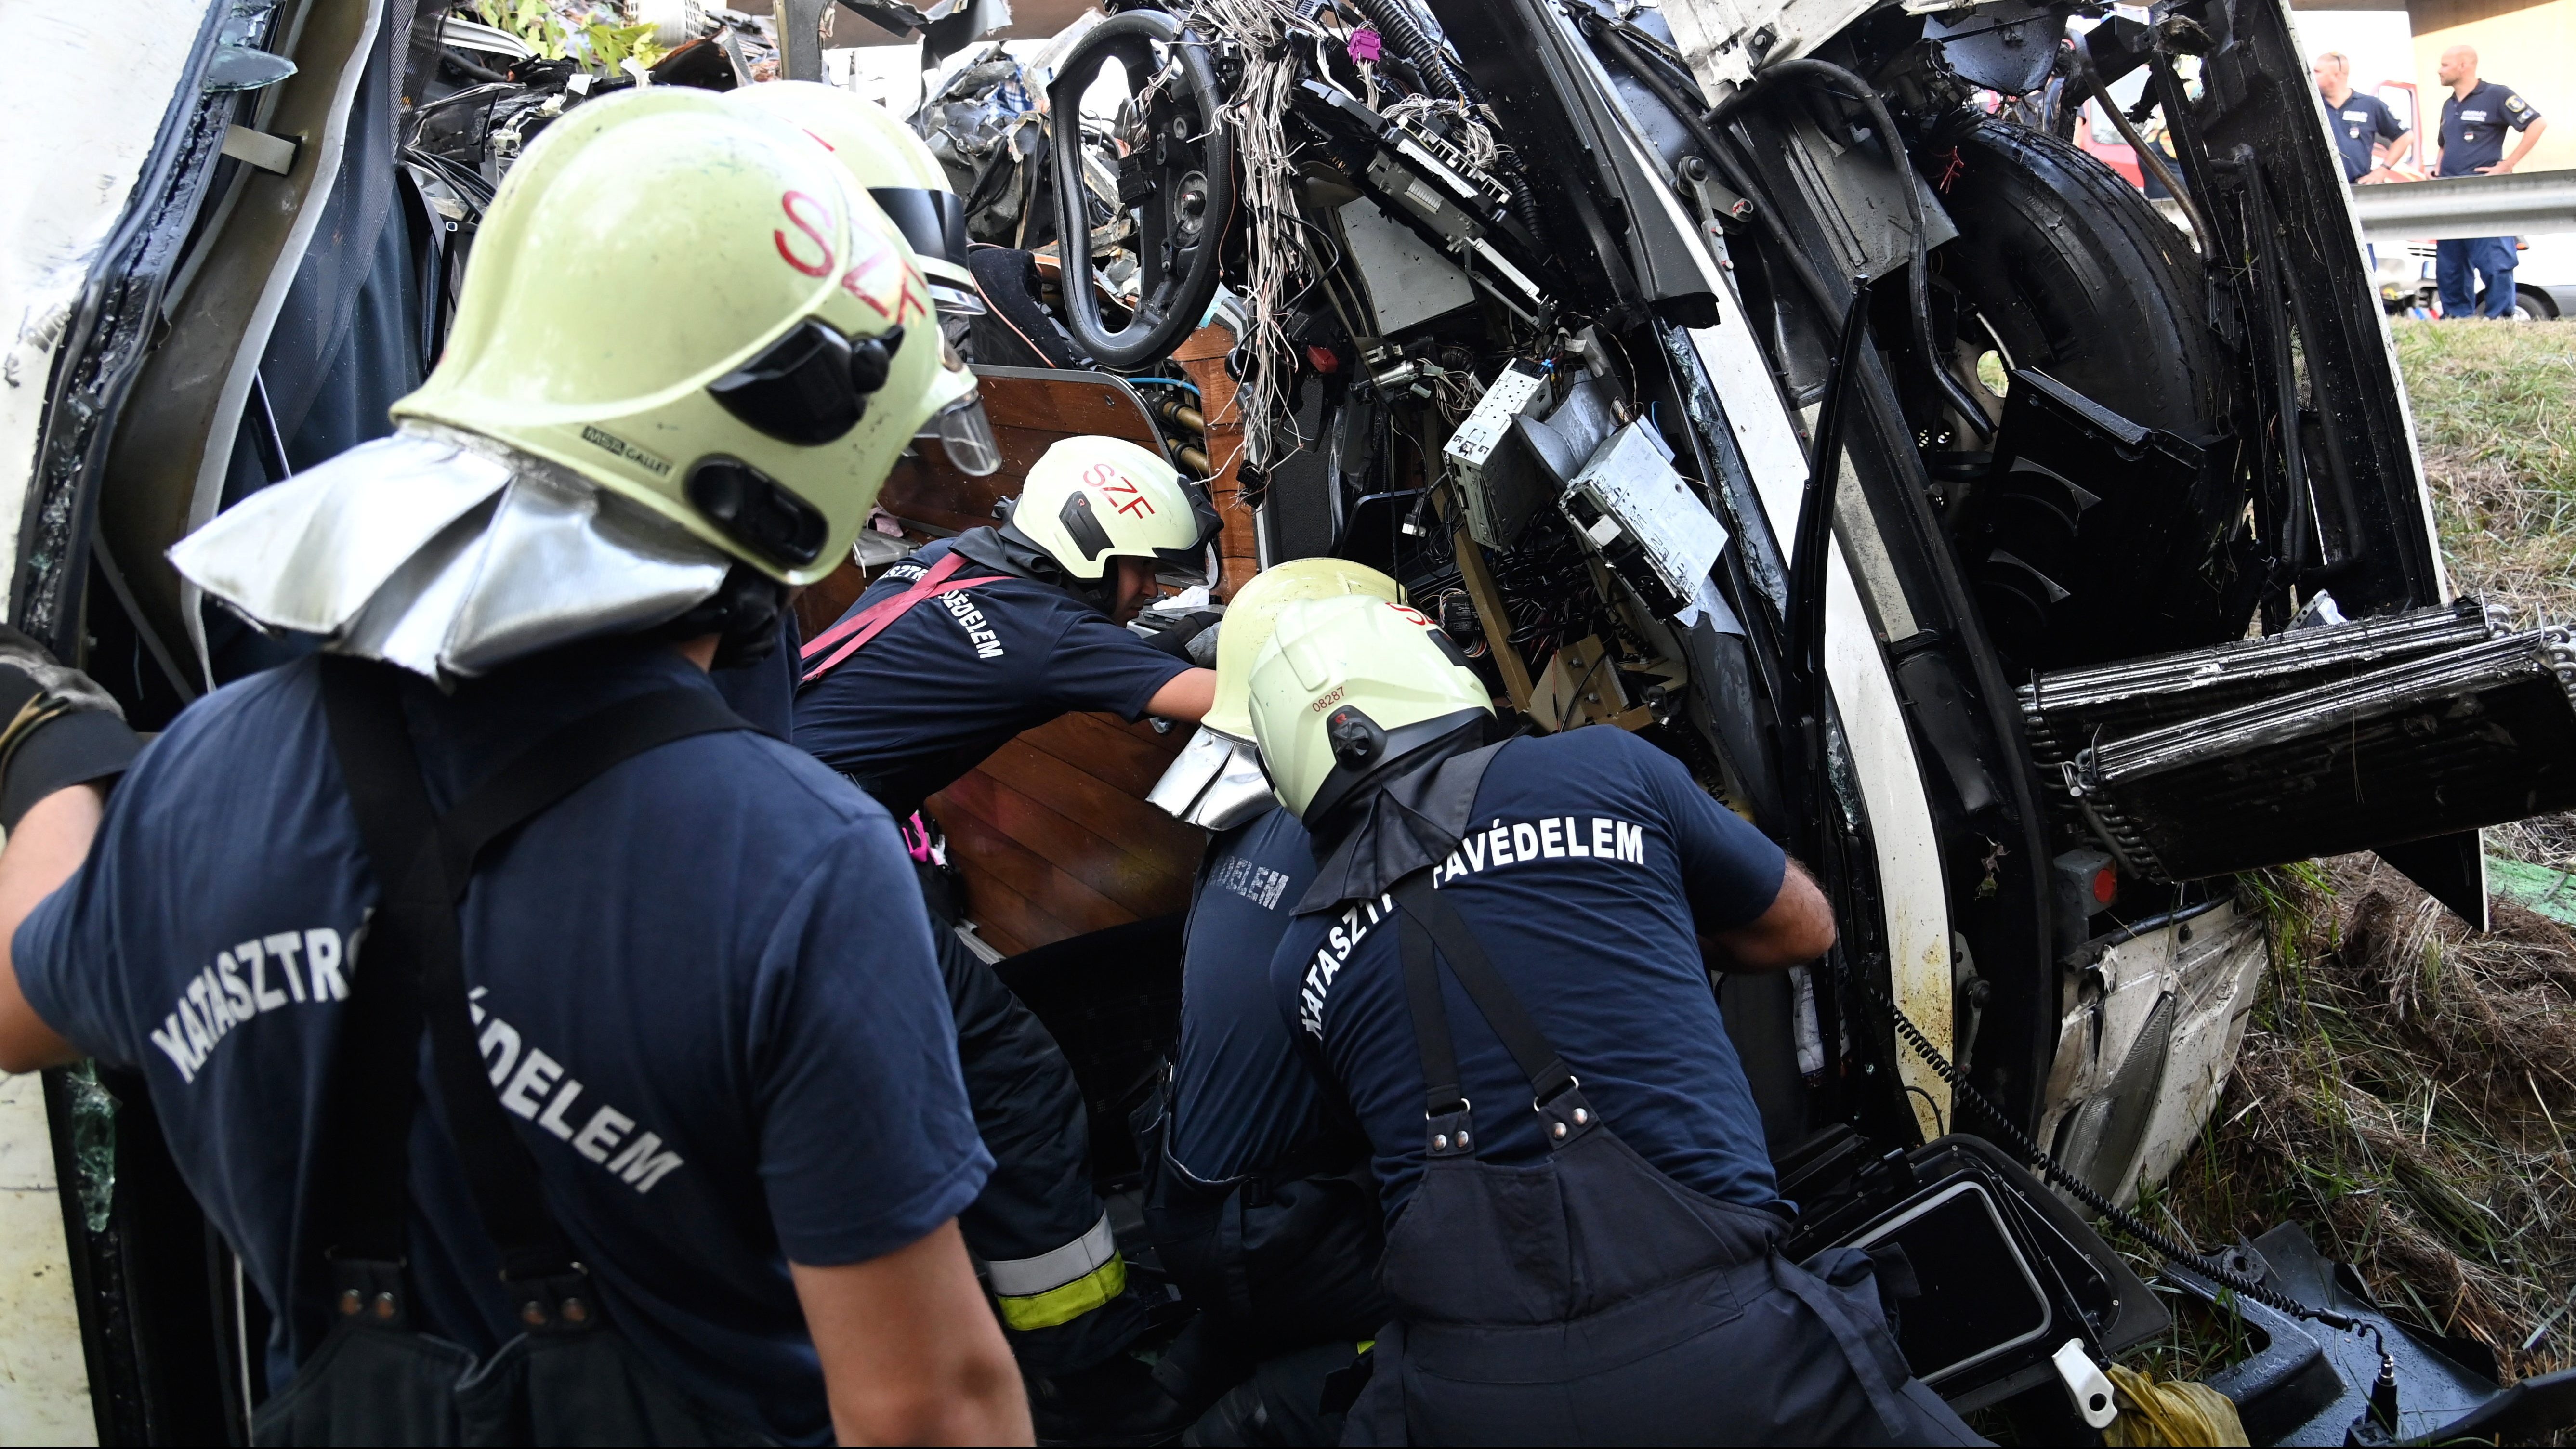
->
[15,643,992,1441]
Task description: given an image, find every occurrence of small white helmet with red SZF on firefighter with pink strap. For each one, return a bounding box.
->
[1010,438,1219,582]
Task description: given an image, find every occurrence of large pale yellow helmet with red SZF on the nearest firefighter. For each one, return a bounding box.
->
[394,85,997,584]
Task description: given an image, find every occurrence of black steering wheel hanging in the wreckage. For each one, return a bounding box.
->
[1049,10,1234,368]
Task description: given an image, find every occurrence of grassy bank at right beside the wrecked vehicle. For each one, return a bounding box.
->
[2143,322,2576,1377]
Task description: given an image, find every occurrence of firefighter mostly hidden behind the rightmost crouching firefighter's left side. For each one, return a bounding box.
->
[1139,559,1404,1444]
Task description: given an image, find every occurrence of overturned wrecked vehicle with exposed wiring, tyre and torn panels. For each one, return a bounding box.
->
[15,0,2576,1444]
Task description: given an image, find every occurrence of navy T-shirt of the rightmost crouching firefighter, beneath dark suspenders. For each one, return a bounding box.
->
[1270,729,1788,1220]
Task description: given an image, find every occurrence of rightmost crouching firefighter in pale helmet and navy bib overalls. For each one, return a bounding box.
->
[1252,600,1976,1444]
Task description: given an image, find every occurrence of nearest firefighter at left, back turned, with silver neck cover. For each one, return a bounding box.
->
[0,88,1030,1444]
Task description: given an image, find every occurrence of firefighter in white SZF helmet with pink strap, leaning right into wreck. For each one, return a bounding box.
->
[796,427,1219,1439]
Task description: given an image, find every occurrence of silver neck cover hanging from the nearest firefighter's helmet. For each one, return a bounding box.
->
[170,422,732,687]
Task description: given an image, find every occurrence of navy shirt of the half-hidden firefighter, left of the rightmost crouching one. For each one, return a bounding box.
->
[1172,808,1327,1181]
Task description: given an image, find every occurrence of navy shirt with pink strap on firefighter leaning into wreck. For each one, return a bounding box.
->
[796,540,1190,813]
